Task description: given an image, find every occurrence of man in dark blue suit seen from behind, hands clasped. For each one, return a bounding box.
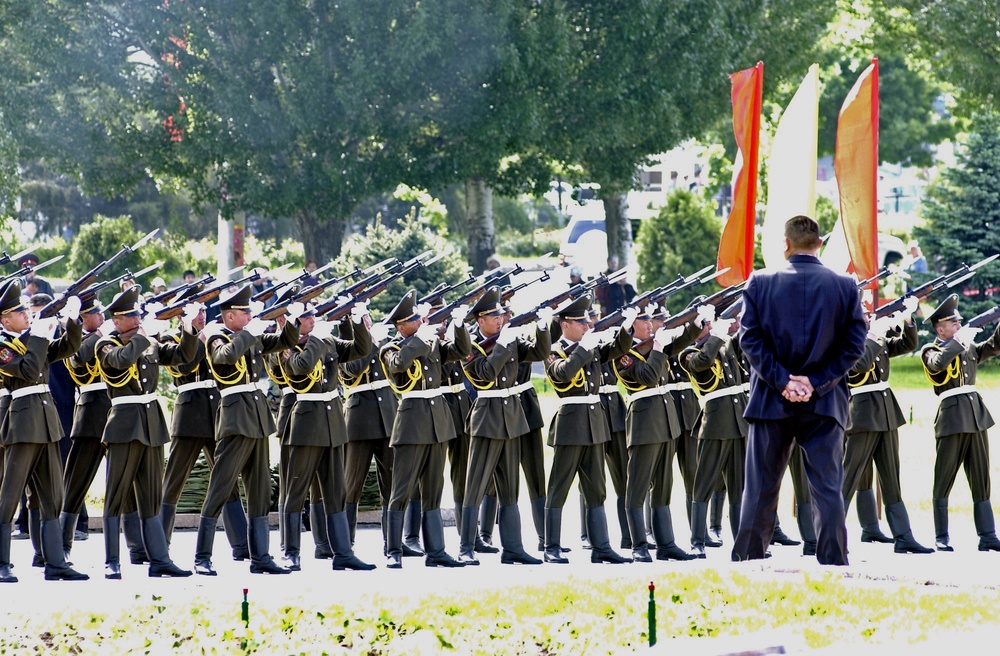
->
[733,216,868,565]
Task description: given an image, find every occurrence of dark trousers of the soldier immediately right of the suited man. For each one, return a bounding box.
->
[843,430,908,507]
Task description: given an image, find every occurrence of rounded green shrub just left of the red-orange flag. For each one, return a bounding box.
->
[636,189,722,303]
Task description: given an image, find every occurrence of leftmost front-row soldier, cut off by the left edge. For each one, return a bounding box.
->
[0,280,89,583]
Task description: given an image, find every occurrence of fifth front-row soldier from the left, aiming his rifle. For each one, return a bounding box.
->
[379,289,471,569]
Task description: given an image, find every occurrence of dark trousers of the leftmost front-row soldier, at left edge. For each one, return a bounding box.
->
[0,442,63,524]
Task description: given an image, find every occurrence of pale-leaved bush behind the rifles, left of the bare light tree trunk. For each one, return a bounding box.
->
[334,216,467,317]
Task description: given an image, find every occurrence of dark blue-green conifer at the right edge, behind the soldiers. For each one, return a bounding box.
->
[913,113,1000,317]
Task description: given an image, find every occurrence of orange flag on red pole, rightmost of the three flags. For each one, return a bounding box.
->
[833,57,878,291]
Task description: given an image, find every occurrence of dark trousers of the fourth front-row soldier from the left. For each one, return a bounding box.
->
[284,445,347,515]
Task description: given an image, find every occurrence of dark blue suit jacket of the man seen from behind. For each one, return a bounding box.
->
[740,255,868,427]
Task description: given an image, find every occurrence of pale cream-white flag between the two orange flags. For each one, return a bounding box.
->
[760,64,819,267]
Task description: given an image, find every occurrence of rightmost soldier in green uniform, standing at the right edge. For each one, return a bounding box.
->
[920,294,1000,551]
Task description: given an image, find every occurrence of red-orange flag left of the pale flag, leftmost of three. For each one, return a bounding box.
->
[717,62,764,286]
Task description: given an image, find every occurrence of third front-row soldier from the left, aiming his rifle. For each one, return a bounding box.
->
[195,285,299,576]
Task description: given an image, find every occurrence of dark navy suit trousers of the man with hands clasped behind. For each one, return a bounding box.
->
[733,414,847,565]
